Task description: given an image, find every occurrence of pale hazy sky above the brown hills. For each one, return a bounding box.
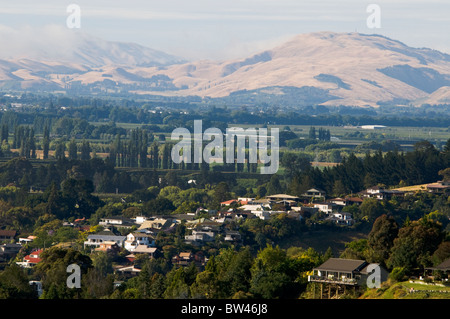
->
[0,0,450,60]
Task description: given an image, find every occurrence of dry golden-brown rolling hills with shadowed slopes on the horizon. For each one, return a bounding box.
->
[0,32,450,107]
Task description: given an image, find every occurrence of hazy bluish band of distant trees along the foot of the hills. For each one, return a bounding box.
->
[0,94,450,132]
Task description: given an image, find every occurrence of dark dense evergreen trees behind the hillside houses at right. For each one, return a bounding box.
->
[281,140,450,196]
